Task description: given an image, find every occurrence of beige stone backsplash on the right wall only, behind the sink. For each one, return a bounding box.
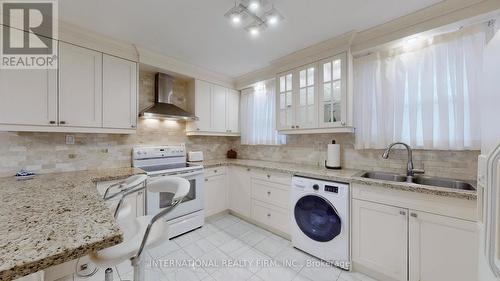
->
[234,134,480,180]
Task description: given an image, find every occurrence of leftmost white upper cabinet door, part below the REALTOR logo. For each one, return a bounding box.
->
[0,69,57,126]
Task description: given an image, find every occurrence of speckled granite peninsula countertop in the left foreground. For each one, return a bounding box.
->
[0,168,144,280]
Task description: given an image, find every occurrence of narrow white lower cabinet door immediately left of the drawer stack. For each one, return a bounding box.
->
[228,167,252,218]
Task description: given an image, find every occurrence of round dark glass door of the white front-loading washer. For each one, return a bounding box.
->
[294,195,342,242]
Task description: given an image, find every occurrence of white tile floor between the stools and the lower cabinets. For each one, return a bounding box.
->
[75,214,375,281]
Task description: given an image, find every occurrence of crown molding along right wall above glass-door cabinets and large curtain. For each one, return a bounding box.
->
[235,0,500,89]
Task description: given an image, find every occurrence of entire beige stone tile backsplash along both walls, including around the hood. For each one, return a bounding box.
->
[0,72,479,179]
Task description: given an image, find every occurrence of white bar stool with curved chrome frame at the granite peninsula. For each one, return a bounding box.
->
[90,177,190,281]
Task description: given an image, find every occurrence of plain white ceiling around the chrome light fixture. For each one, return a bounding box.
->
[59,0,440,77]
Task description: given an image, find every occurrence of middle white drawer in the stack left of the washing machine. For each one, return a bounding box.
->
[252,179,290,209]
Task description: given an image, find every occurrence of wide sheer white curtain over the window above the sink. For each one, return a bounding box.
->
[354,26,485,150]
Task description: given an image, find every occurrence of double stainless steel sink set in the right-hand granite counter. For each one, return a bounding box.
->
[360,172,476,190]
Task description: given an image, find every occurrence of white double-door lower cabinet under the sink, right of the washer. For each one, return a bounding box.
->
[352,199,478,281]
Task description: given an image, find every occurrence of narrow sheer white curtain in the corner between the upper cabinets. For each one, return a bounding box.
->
[240,79,286,145]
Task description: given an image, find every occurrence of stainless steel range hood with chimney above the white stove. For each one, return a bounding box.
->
[139,73,198,121]
